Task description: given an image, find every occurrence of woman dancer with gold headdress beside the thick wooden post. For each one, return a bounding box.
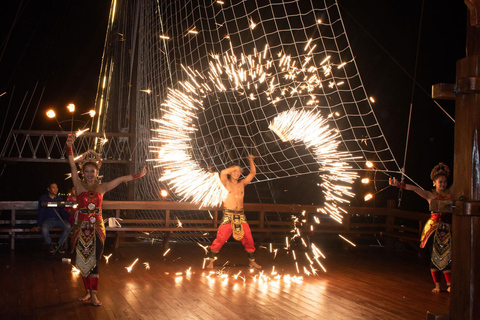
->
[389,162,452,292]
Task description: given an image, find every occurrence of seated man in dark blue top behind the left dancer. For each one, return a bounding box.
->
[34,182,71,253]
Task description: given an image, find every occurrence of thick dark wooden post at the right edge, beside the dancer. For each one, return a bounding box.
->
[450,0,480,320]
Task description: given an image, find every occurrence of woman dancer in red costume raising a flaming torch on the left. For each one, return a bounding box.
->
[65,134,146,306]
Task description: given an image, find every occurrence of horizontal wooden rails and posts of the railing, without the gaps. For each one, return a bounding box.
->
[0,201,430,249]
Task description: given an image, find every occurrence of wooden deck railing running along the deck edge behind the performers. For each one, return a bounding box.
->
[0,201,429,249]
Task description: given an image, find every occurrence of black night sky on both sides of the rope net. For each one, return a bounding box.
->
[0,0,466,210]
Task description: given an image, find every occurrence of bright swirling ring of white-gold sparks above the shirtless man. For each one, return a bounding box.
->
[151,42,357,212]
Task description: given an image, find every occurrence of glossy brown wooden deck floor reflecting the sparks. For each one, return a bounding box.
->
[0,240,450,320]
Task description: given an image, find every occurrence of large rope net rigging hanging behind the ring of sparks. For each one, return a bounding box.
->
[96,0,400,230]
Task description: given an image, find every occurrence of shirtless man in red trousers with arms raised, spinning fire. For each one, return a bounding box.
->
[207,155,261,269]
